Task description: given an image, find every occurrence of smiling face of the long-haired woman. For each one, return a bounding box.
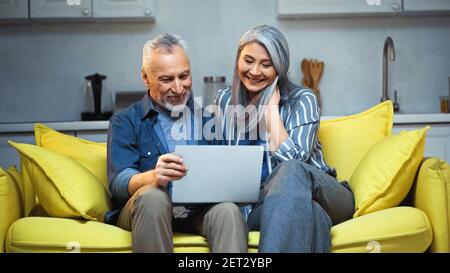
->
[238,42,277,98]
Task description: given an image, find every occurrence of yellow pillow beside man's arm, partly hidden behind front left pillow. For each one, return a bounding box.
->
[34,123,108,191]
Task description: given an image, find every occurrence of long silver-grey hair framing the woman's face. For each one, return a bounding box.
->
[231,25,294,106]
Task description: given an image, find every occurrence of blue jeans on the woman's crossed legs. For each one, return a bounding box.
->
[247,160,354,253]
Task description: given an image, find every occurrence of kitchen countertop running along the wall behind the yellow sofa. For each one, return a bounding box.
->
[0,114,450,134]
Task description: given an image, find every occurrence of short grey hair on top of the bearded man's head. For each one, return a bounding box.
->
[142,33,188,68]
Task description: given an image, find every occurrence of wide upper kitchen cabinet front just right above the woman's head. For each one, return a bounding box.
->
[278,0,402,19]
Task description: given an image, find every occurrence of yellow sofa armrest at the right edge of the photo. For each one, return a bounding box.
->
[412,157,450,252]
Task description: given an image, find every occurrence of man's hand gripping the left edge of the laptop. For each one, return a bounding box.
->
[154,154,188,187]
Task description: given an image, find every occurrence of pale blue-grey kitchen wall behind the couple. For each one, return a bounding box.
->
[0,0,450,122]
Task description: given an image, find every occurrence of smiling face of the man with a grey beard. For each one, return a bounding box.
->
[142,46,192,110]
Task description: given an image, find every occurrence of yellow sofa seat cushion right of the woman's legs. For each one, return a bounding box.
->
[331,207,433,253]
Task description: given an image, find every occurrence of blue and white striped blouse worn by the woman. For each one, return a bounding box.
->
[214,87,336,177]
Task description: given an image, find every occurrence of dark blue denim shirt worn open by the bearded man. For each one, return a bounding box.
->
[105,93,216,224]
